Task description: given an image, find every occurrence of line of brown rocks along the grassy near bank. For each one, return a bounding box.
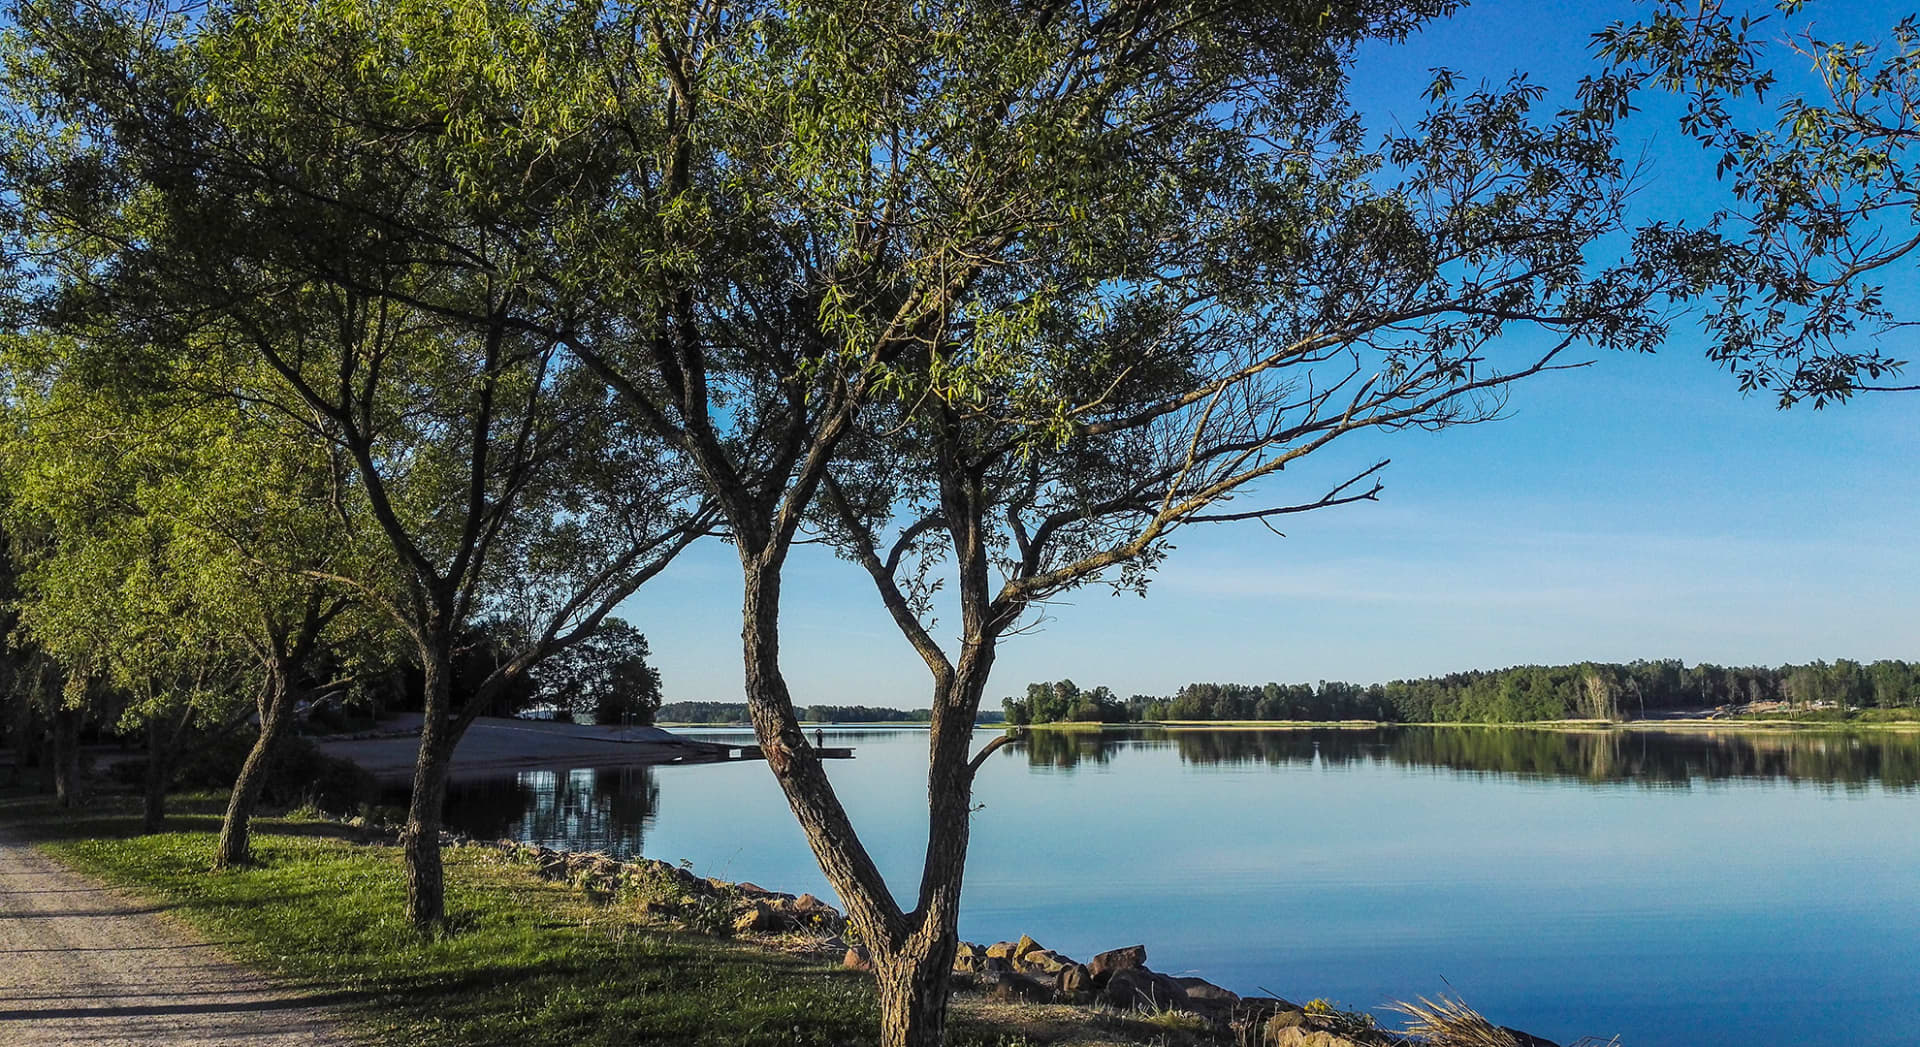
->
[472,836,1557,1047]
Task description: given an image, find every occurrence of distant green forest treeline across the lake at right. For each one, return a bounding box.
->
[1002,659,1920,724]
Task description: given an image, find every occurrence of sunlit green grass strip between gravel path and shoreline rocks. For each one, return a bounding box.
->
[0,799,879,1047]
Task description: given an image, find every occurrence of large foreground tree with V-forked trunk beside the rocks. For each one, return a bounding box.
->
[445,2,1661,1045]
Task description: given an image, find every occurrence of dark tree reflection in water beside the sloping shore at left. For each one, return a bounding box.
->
[447,767,660,859]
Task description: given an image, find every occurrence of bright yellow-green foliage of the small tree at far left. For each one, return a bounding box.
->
[0,344,366,728]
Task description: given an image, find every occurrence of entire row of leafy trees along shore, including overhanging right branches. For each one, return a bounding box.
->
[0,0,1920,1047]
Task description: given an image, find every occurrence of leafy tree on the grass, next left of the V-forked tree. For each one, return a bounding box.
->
[4,4,707,914]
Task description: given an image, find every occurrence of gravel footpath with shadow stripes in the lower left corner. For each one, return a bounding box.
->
[0,828,353,1047]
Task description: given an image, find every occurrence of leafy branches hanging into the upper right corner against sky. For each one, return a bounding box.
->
[1596,0,1920,407]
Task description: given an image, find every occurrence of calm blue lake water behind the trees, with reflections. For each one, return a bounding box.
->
[420,728,1920,1047]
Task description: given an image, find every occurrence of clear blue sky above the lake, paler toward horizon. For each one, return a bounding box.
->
[622,0,1920,707]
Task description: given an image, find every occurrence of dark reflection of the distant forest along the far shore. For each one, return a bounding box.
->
[1010,726,1920,790]
